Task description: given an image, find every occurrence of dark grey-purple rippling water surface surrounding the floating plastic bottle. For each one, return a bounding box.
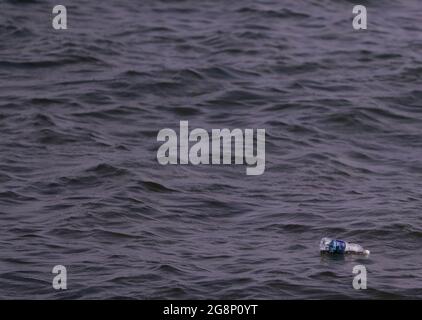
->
[0,0,422,299]
